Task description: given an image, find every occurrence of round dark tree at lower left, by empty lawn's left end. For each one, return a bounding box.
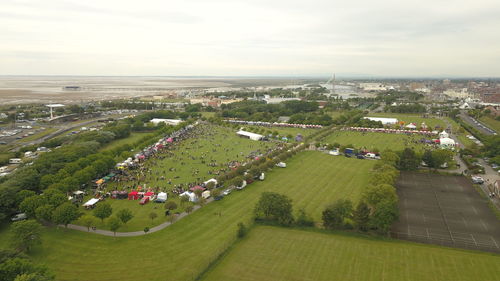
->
[11,220,42,251]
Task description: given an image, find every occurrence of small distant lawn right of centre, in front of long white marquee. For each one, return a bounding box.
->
[323,131,425,151]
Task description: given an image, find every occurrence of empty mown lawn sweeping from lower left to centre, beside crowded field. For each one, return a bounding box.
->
[0,151,375,280]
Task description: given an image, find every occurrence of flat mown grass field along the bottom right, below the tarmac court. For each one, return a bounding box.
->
[203,226,500,281]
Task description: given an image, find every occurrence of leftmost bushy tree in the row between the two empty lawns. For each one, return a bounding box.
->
[254,192,294,225]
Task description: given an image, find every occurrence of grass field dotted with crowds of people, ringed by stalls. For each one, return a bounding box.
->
[98,123,277,199]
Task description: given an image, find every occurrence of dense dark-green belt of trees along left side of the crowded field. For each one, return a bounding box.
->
[0,110,193,220]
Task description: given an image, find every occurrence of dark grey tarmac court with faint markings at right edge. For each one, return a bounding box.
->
[391,172,500,253]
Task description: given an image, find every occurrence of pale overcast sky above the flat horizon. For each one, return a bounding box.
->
[0,0,500,77]
